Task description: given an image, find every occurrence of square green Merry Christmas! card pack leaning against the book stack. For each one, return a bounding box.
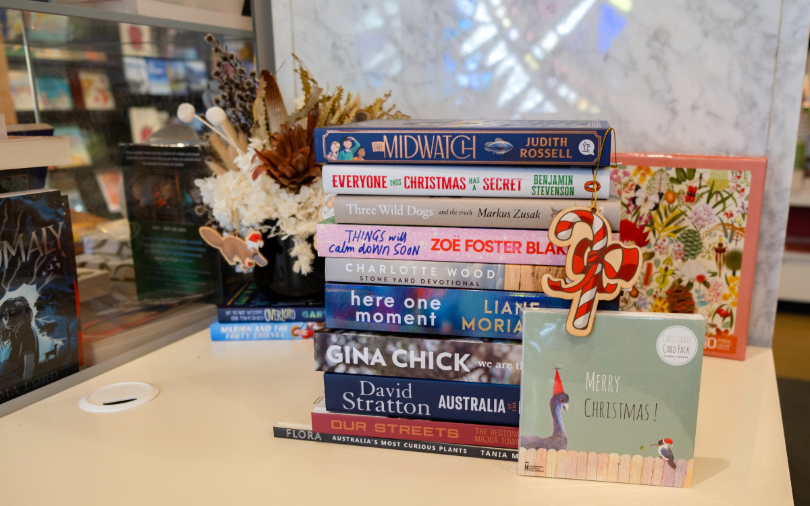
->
[518,310,706,487]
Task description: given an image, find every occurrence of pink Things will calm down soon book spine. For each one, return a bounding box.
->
[316,217,619,266]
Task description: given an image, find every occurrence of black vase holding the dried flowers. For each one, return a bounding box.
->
[253,236,326,302]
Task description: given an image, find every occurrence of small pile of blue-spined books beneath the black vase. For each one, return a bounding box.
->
[210,282,324,341]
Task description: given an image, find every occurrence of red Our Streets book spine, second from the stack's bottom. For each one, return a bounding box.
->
[312,411,518,449]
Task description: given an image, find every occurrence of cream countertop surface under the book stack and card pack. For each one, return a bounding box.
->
[0,331,793,506]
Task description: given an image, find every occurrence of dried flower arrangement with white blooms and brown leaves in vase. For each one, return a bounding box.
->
[185,34,407,275]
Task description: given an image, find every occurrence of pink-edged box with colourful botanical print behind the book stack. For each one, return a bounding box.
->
[612,153,767,360]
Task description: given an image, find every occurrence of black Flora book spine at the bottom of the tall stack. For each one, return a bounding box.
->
[273,427,518,462]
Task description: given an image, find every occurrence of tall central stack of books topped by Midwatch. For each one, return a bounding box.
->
[276,120,620,460]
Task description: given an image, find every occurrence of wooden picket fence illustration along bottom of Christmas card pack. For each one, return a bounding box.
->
[518,448,694,488]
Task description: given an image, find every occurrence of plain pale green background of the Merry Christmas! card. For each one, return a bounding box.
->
[520,310,705,460]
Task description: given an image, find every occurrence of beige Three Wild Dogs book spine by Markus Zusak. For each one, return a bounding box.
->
[334,195,621,232]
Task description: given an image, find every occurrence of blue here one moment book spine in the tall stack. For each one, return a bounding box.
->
[326,283,618,339]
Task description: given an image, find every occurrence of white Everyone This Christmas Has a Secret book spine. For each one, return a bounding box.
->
[323,164,610,199]
